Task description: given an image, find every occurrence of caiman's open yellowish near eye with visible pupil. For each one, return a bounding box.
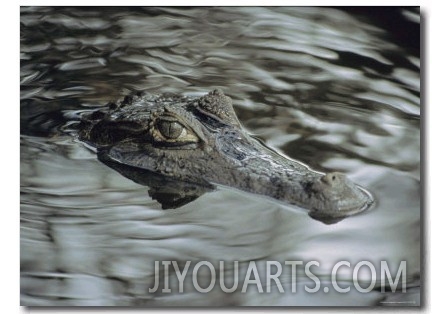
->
[151,115,199,146]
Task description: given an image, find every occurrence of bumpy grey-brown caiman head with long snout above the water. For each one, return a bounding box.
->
[80,90,372,221]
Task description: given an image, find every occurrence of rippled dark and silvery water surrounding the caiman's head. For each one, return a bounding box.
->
[21,7,421,306]
